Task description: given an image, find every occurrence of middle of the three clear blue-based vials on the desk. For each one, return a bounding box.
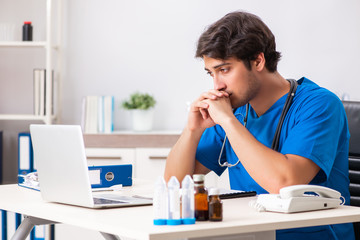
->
[166,176,181,225]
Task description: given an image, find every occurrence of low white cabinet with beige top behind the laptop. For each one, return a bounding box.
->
[84,131,180,181]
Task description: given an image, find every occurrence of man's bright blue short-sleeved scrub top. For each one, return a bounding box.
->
[196,78,354,240]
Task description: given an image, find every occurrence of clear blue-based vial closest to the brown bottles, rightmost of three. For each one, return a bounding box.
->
[181,175,195,224]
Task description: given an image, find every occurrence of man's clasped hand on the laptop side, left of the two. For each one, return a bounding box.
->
[188,90,231,131]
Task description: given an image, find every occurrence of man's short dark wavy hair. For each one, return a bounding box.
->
[195,11,281,72]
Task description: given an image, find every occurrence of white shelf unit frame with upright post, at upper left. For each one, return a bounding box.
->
[0,0,62,124]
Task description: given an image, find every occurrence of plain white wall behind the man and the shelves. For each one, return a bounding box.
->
[0,0,360,182]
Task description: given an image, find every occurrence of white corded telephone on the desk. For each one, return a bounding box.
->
[250,185,345,213]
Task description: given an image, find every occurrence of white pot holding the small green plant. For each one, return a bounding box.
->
[131,108,154,131]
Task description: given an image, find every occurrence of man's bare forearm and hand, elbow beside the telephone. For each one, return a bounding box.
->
[205,95,320,193]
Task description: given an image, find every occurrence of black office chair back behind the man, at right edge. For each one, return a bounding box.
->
[343,101,360,240]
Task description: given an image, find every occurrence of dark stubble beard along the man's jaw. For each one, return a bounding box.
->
[230,74,261,108]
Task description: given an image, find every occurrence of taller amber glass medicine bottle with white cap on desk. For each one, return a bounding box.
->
[193,174,209,221]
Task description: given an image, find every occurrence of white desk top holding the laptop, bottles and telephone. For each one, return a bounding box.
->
[0,182,360,240]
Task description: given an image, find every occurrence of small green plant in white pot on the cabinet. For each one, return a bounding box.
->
[122,92,156,131]
